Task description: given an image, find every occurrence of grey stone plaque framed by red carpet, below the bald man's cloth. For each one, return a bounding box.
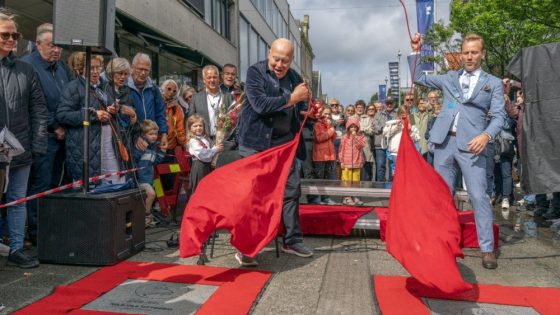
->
[82,279,218,314]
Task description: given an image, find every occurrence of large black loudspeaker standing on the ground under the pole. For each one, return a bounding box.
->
[37,189,146,266]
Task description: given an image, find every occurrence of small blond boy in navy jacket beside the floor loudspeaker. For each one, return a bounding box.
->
[134,119,166,227]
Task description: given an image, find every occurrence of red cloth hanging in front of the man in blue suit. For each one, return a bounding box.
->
[387,119,472,293]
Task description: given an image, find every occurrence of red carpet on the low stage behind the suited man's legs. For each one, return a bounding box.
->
[375,207,500,249]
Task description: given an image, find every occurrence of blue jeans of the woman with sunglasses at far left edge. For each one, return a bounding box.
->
[0,165,31,253]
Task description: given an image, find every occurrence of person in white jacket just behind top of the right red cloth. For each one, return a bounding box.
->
[383,106,420,180]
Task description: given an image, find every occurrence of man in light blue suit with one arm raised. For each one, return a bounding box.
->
[408,34,505,269]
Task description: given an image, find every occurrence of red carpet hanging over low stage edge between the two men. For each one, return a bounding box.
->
[299,204,373,235]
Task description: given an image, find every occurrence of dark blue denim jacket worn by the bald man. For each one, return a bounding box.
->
[238,60,307,157]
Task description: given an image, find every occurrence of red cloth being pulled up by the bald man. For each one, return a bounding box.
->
[179,135,299,257]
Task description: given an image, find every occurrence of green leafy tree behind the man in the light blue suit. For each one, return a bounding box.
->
[426,0,560,77]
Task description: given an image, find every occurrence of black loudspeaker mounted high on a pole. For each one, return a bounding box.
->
[53,0,115,54]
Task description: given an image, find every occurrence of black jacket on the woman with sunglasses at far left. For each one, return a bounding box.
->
[0,53,48,168]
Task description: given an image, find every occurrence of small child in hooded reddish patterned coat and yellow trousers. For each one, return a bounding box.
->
[338,116,366,205]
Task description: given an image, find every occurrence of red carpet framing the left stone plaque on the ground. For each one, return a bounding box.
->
[14,261,272,315]
